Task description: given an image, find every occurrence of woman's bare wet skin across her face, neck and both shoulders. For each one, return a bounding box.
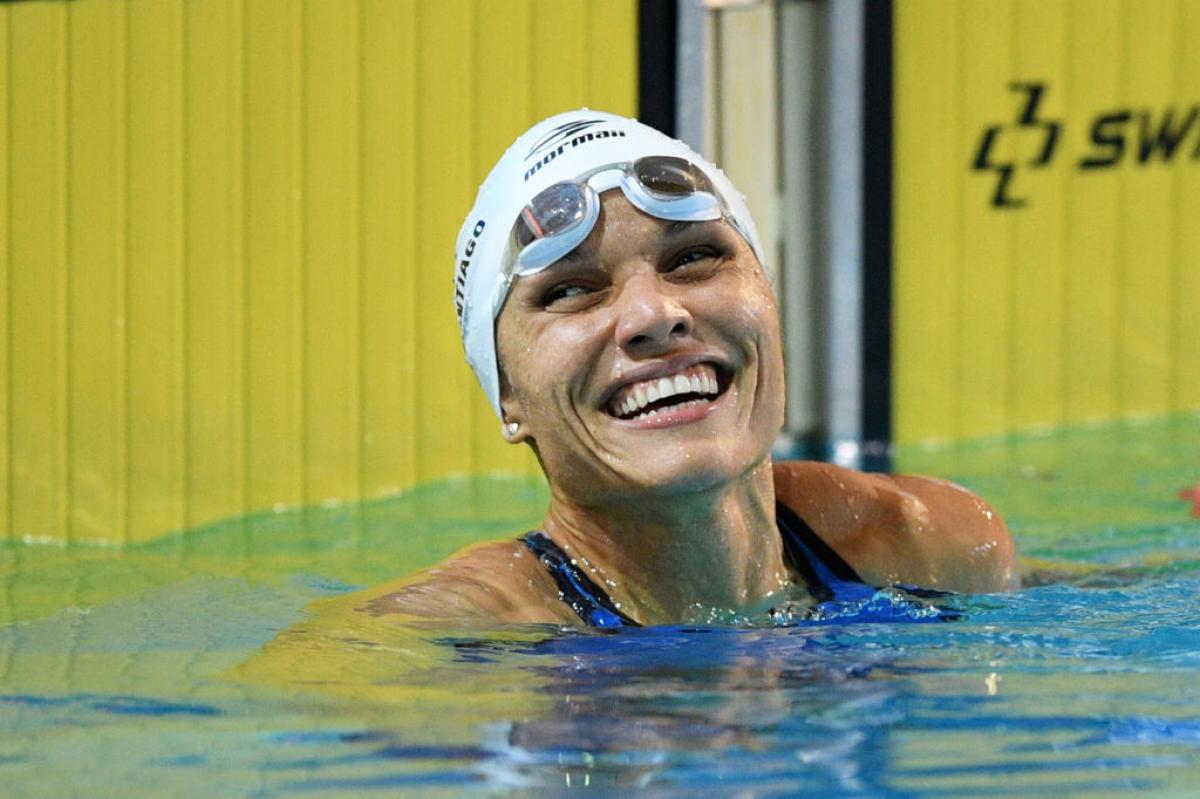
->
[358,191,1013,624]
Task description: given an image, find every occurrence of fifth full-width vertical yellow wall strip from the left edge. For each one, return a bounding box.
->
[242,1,305,507]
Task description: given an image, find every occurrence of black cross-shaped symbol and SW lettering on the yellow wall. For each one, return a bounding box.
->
[971,82,1200,209]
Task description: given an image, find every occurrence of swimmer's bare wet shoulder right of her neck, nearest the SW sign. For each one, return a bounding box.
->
[775,461,1016,593]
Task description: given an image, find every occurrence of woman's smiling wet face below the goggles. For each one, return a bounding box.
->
[497,191,784,501]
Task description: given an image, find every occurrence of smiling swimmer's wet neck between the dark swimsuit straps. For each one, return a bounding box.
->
[545,461,788,624]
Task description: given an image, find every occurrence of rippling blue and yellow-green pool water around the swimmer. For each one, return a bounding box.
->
[0,415,1200,797]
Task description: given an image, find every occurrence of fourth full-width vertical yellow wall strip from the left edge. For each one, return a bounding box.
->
[184,0,246,525]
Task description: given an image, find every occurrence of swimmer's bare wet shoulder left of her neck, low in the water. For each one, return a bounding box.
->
[360,540,571,624]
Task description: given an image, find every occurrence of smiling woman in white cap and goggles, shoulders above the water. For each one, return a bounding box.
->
[366,110,1014,626]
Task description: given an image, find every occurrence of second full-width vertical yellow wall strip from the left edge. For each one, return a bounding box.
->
[67,2,126,539]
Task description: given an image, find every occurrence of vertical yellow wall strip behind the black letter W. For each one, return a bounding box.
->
[1117,0,1178,414]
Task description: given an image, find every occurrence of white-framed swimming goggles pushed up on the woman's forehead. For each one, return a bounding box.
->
[504,156,725,279]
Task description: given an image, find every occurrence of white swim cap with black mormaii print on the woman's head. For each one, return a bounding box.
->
[454,108,763,419]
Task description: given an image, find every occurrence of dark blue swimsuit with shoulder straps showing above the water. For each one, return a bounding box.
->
[522,503,949,627]
